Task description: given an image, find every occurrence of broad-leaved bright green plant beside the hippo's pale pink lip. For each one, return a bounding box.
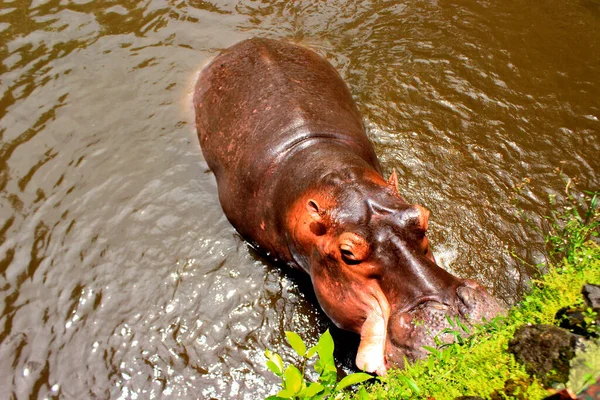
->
[265,330,372,400]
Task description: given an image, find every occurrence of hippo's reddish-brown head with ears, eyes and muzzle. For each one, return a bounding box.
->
[288,170,502,375]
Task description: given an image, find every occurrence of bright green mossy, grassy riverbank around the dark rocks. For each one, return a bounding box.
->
[355,193,600,400]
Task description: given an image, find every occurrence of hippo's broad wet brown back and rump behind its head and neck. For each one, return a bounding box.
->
[194,38,379,255]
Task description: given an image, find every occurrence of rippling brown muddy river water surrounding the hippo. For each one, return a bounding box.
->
[0,0,600,399]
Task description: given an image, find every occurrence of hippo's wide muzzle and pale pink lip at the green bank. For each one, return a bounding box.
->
[356,280,504,375]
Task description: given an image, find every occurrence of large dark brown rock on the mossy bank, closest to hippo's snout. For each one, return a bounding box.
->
[508,325,581,386]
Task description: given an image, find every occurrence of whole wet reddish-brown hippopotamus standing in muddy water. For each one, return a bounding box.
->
[193,38,502,375]
